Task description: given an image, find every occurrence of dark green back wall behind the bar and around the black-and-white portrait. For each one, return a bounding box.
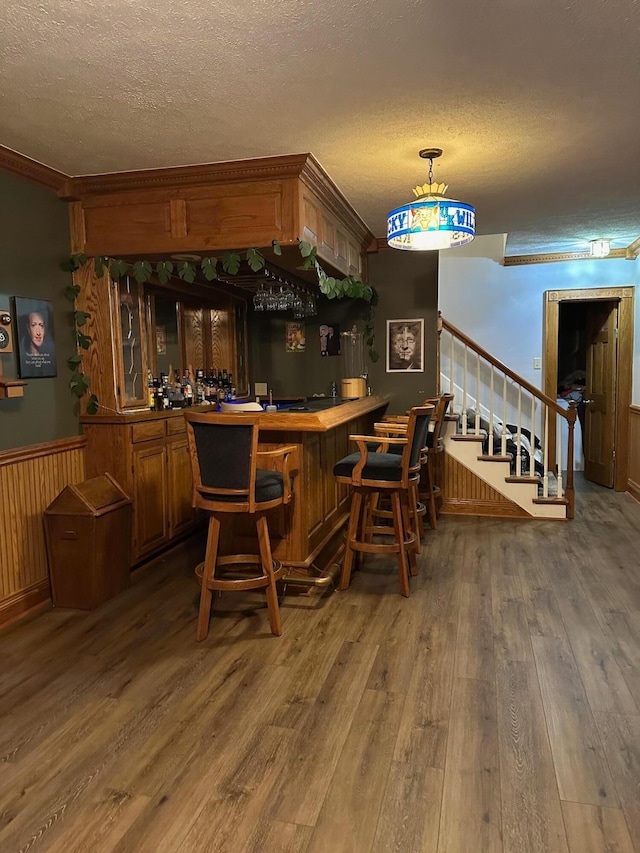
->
[248,250,438,412]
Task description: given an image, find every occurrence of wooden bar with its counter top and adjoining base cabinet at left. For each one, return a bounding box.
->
[81,395,389,586]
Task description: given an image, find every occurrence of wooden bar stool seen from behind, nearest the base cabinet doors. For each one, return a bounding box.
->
[185,412,295,640]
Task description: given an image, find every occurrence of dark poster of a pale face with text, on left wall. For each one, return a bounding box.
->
[13,296,58,379]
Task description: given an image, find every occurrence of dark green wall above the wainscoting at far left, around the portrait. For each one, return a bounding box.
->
[0,173,80,450]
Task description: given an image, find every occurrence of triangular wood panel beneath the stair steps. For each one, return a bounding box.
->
[435,453,529,518]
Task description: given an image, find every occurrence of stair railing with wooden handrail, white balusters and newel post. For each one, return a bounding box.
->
[438,317,577,518]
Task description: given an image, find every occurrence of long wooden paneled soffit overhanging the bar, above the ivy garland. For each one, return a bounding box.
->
[60,154,374,276]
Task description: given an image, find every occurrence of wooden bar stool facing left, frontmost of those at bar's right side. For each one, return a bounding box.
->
[333,406,433,596]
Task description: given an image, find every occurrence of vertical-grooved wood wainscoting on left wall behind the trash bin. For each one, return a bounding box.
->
[0,436,86,627]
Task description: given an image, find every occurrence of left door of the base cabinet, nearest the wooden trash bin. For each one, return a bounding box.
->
[133,444,169,557]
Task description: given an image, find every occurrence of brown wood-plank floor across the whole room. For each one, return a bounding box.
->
[0,476,640,853]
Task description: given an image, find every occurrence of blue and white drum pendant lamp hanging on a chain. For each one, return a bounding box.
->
[387,148,476,252]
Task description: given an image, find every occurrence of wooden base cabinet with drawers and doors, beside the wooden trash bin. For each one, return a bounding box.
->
[82,410,198,565]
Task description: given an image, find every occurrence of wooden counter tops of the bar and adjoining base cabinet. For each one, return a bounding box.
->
[80,394,391,432]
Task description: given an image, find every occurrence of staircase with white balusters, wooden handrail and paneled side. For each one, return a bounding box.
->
[438,318,577,519]
